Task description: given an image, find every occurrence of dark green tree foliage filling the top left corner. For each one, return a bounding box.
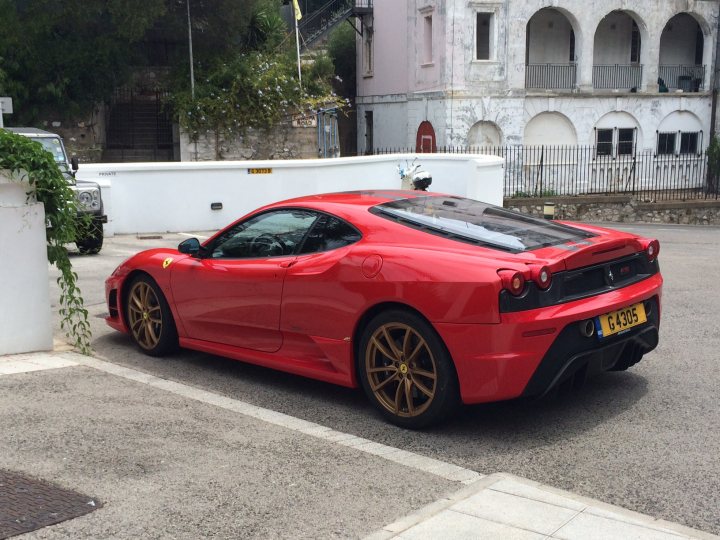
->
[0,0,256,125]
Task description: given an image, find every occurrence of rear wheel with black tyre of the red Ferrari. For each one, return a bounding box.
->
[357,310,460,429]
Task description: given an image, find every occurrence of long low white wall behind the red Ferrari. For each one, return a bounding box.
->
[78,154,503,236]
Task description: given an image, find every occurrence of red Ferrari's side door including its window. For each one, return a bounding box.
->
[171,209,317,352]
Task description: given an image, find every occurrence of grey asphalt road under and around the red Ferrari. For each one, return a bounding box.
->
[49,225,720,534]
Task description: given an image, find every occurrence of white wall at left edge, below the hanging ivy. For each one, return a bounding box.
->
[0,174,53,355]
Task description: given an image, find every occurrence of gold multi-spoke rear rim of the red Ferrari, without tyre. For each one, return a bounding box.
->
[365,322,437,418]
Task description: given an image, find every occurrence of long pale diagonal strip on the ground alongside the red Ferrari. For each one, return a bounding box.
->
[68,353,485,484]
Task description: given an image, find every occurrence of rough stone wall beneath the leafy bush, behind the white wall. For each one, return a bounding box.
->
[180,118,318,161]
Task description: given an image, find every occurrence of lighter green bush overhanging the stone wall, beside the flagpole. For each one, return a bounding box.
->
[172,0,339,159]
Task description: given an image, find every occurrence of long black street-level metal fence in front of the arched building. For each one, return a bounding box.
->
[375,146,720,201]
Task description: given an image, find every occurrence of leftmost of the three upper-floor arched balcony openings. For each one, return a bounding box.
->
[525,8,577,89]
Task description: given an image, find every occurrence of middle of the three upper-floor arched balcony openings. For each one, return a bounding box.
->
[593,11,644,92]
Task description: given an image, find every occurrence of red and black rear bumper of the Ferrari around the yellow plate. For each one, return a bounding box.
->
[435,274,662,404]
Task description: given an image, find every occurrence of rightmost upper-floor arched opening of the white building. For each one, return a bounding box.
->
[658,13,705,92]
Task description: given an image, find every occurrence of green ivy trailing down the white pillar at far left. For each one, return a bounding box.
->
[0,129,91,354]
